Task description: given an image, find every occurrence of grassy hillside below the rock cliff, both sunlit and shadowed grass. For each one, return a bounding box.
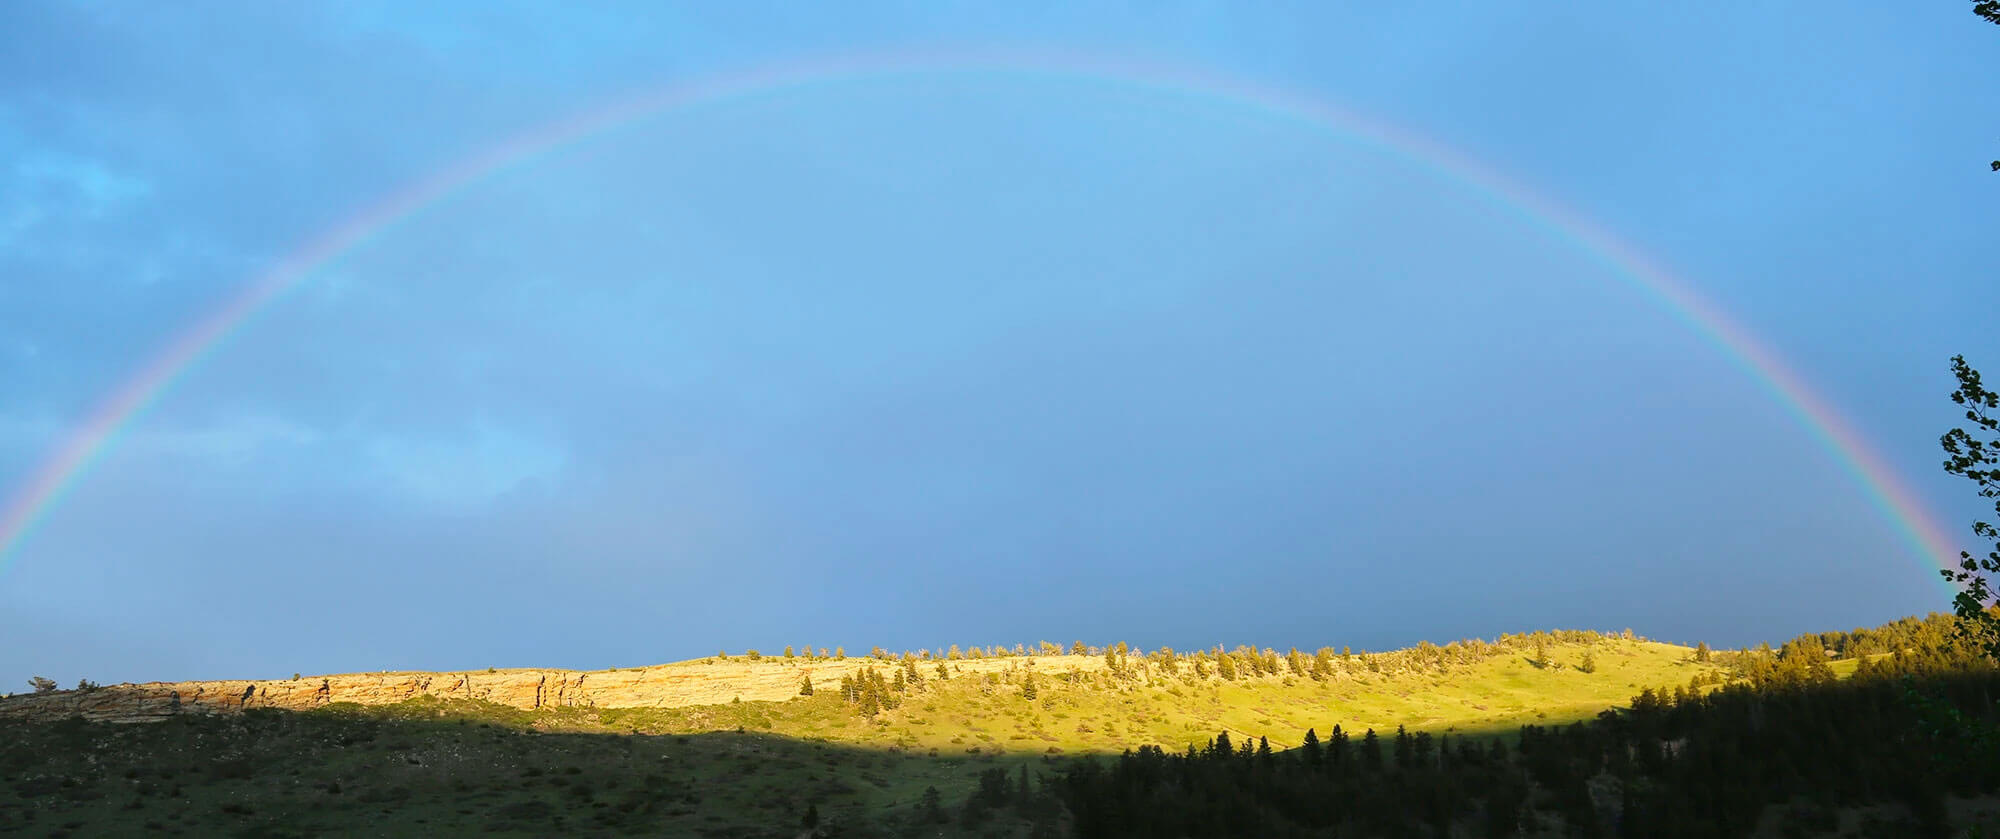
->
[0,639,1710,835]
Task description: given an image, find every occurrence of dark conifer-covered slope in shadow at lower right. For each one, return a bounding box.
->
[1056,619,2000,837]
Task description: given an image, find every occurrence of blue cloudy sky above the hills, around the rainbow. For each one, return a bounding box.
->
[0,0,2000,689]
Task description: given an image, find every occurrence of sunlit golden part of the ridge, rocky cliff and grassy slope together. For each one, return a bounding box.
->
[0,631,1720,753]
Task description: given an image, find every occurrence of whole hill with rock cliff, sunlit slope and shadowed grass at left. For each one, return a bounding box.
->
[0,631,1722,835]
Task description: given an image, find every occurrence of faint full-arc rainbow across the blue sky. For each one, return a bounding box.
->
[0,47,1958,583]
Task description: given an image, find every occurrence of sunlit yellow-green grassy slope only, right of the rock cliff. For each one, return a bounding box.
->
[624,639,1716,753]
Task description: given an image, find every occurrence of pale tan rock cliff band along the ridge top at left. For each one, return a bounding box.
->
[0,655,1104,723]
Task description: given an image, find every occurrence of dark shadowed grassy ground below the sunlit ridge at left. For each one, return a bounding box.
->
[0,699,1054,837]
